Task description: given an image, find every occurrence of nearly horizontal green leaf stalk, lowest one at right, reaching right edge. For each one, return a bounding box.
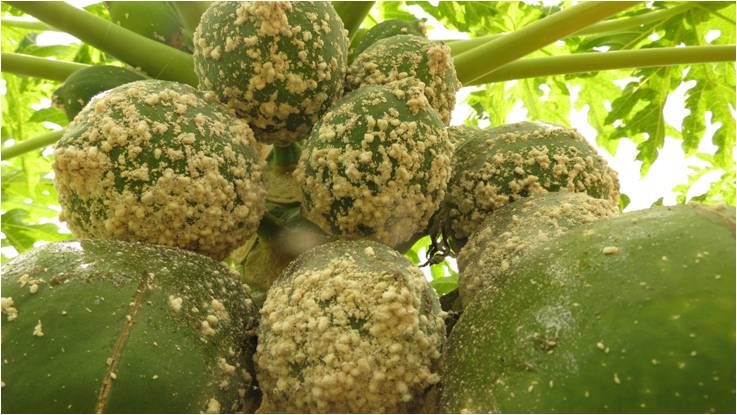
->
[464,45,735,86]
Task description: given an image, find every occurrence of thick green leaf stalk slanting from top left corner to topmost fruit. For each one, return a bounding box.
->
[7,1,197,86]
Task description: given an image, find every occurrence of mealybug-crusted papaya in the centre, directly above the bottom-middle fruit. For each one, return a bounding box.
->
[294,78,452,247]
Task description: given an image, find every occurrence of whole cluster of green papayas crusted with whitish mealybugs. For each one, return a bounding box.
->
[2,2,735,413]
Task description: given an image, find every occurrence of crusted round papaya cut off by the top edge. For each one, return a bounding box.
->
[194,1,348,144]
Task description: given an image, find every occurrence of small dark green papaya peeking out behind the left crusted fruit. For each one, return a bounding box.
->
[53,65,146,120]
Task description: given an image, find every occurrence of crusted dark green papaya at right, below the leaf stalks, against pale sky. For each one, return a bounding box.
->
[432,121,619,252]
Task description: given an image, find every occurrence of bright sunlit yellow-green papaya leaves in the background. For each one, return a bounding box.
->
[0,1,735,294]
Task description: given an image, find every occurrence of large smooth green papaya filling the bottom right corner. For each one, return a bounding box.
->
[441,205,735,413]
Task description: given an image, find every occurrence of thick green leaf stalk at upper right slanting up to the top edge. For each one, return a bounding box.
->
[455,1,638,84]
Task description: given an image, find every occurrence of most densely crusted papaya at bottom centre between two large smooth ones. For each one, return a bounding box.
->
[254,241,445,413]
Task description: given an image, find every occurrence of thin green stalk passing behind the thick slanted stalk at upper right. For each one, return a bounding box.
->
[446,3,697,56]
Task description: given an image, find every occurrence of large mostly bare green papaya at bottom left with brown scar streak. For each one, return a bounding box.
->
[2,241,258,413]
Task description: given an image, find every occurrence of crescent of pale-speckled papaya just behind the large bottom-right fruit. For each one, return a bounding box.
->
[458,191,619,304]
